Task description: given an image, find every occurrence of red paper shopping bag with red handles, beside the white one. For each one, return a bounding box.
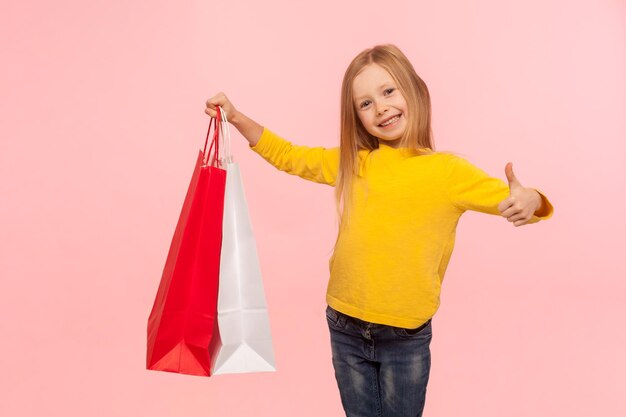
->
[146,111,226,376]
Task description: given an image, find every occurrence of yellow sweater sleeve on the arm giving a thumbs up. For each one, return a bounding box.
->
[447,156,554,224]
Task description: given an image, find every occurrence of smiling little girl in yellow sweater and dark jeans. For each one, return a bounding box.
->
[205,45,553,417]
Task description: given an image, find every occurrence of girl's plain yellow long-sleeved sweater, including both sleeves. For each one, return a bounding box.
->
[251,128,554,328]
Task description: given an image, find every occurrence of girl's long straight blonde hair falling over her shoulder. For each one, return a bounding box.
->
[335,44,435,234]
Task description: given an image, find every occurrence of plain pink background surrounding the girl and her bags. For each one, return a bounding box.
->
[0,0,626,417]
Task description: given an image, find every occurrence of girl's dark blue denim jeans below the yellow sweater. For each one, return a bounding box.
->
[326,306,432,417]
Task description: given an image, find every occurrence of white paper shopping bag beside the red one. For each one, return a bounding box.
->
[211,108,276,375]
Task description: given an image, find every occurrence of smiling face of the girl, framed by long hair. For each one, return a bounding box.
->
[352,63,408,148]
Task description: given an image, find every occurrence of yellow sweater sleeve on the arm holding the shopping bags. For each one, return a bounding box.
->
[250,127,339,186]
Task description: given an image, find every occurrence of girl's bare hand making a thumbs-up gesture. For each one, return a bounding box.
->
[498,162,542,227]
